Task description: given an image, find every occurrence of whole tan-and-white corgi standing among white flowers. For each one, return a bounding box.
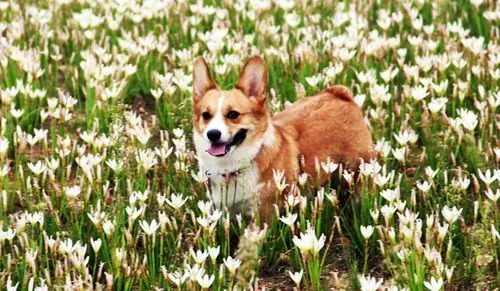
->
[193,56,373,220]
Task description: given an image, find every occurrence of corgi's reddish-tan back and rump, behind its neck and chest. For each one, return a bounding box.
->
[272,86,373,181]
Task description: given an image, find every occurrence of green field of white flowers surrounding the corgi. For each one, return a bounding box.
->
[0,0,500,290]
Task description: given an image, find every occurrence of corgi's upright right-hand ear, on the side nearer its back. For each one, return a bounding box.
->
[236,56,267,101]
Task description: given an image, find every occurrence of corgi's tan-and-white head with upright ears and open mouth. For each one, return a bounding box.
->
[193,57,269,157]
